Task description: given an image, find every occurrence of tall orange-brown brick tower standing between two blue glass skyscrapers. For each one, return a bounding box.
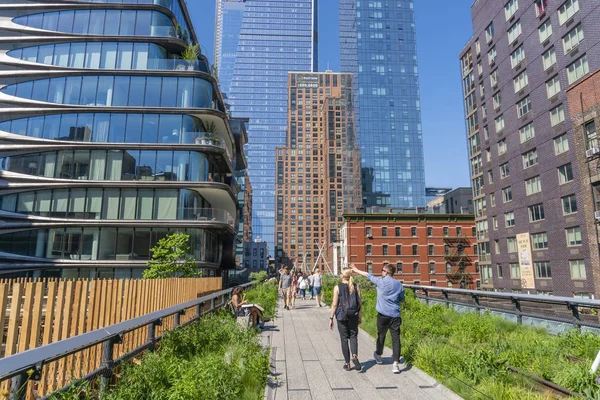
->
[275,71,362,269]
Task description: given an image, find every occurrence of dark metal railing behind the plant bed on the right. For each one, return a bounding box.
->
[404,284,600,333]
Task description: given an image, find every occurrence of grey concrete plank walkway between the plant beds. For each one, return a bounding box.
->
[263,299,460,400]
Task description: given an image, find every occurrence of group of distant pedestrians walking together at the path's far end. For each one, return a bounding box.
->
[279,267,323,310]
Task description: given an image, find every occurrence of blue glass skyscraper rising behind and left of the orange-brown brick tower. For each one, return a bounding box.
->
[215,0,318,249]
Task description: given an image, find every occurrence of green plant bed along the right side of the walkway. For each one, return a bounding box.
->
[323,277,600,400]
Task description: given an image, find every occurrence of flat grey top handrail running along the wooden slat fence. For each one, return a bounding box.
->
[0,282,252,389]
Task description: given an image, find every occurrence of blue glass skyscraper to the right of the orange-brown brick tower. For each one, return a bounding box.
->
[340,0,425,207]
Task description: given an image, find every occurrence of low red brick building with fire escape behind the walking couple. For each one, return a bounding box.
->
[340,214,480,289]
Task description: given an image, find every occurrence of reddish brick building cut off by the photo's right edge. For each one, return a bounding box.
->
[567,70,600,298]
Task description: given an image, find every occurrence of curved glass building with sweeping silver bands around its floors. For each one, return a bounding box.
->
[0,0,247,278]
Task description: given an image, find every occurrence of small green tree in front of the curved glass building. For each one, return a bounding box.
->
[143,233,201,279]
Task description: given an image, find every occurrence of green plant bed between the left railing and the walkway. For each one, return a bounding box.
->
[51,311,269,400]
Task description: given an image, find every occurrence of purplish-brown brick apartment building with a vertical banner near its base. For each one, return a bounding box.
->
[460,0,600,296]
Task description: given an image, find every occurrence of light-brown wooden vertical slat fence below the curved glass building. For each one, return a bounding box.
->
[0,278,222,399]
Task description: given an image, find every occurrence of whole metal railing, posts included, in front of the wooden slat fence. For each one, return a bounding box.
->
[0,283,252,400]
